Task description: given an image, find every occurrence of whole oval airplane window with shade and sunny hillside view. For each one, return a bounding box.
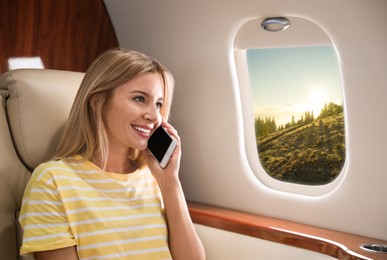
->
[235,18,346,195]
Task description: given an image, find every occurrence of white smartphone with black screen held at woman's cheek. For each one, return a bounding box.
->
[148,126,177,168]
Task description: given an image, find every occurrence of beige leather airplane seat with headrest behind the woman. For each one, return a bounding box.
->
[0,69,84,260]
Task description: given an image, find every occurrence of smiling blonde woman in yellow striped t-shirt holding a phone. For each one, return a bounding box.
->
[20,49,205,259]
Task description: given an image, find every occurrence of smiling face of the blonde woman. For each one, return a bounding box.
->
[104,72,164,153]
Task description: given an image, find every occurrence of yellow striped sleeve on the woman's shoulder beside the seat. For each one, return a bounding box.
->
[19,164,76,255]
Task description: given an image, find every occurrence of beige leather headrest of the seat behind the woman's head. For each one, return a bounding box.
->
[0,69,84,170]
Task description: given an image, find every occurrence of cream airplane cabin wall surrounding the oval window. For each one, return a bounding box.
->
[105,0,387,240]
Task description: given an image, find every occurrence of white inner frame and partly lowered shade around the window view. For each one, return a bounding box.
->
[233,17,348,197]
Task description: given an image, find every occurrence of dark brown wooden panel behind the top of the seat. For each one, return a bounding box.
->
[0,0,118,73]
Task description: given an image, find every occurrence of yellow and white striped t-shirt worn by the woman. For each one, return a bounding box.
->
[19,155,171,259]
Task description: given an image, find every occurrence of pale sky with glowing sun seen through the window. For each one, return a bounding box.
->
[246,46,343,126]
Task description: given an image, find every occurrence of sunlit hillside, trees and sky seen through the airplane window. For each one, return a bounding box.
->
[246,45,345,185]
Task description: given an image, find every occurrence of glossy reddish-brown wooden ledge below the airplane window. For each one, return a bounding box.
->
[188,202,387,260]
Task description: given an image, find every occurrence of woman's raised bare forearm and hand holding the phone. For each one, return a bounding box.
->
[143,122,205,260]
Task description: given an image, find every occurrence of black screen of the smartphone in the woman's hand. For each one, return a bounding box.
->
[148,126,173,162]
